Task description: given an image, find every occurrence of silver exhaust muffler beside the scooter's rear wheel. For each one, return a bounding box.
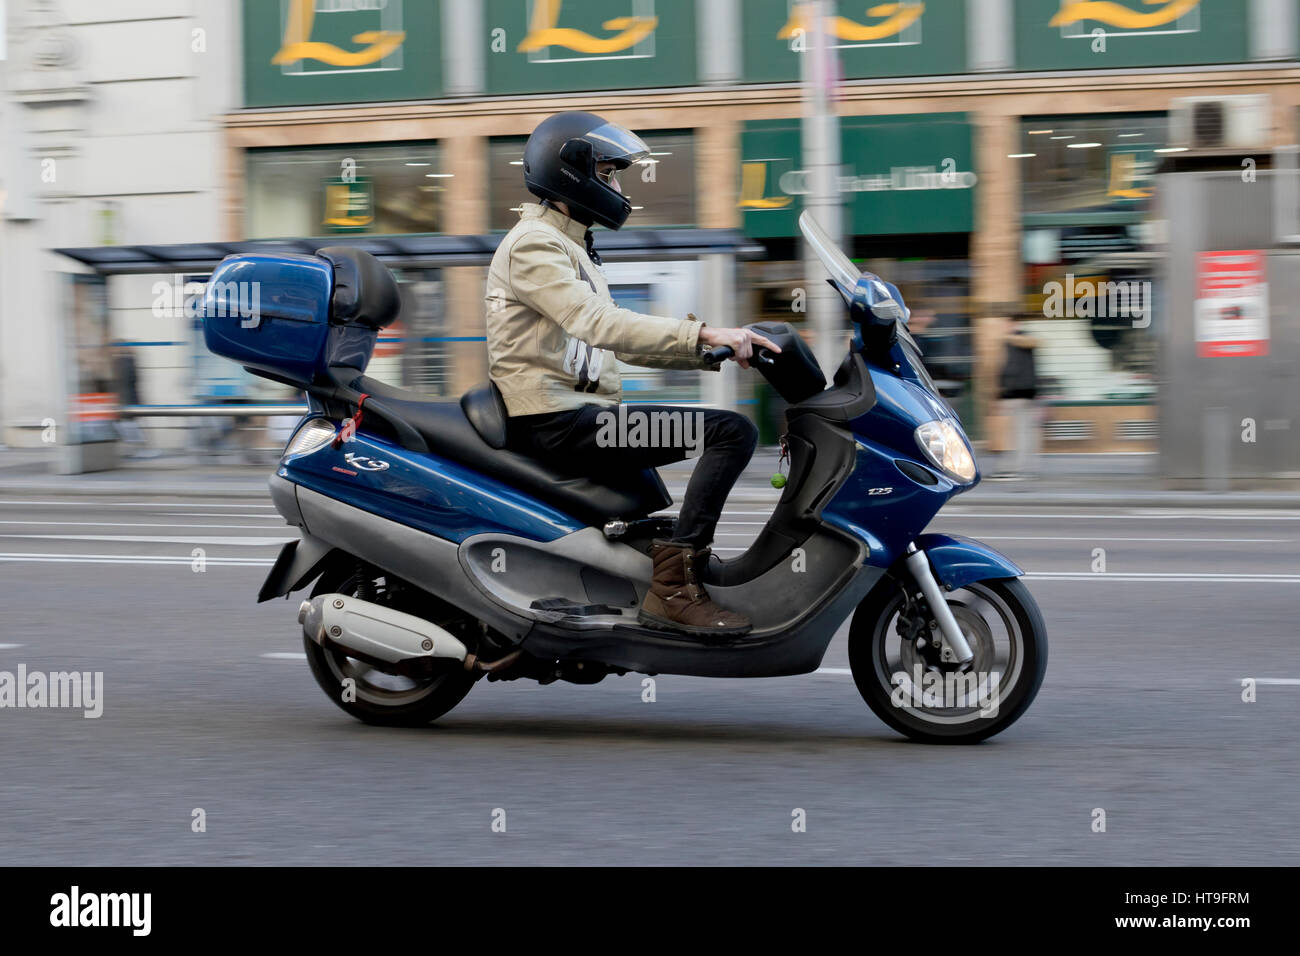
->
[298,594,469,676]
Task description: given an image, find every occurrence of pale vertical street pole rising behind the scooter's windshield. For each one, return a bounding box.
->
[800,0,845,381]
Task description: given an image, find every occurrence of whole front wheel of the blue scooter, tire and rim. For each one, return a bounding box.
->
[849,578,1048,744]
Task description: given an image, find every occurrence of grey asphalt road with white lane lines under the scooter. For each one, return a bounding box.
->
[0,496,1300,865]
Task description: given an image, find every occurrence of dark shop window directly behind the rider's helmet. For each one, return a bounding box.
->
[488,130,696,230]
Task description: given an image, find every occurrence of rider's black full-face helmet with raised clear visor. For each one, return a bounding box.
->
[524,111,650,229]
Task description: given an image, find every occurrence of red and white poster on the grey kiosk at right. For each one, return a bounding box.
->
[1196,250,1269,358]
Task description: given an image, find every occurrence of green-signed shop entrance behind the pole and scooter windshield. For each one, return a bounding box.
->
[740,113,982,436]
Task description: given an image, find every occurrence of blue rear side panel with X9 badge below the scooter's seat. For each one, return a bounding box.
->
[277,432,586,542]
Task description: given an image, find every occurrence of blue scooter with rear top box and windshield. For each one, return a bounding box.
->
[204,213,1047,743]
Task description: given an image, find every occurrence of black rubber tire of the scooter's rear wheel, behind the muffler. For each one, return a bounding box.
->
[303,561,478,727]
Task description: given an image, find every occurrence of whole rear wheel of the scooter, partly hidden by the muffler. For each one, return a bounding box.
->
[303,562,477,727]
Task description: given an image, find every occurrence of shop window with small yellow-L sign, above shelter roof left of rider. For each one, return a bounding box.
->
[244,142,450,239]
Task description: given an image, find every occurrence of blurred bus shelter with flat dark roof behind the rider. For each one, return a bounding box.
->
[56,229,763,473]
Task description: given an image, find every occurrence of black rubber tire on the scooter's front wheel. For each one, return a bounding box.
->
[849,578,1048,744]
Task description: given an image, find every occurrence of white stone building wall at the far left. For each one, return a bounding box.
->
[0,0,242,445]
